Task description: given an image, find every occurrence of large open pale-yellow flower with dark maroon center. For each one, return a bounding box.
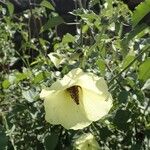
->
[40,68,112,130]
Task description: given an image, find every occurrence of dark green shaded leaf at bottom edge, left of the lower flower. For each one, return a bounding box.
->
[44,134,58,150]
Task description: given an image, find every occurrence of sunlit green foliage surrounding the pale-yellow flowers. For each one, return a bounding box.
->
[0,0,150,150]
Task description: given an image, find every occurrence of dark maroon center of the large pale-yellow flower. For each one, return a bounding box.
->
[67,85,81,105]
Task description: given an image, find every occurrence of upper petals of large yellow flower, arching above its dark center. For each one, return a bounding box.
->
[50,68,108,93]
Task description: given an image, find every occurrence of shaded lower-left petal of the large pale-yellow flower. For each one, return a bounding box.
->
[44,91,91,130]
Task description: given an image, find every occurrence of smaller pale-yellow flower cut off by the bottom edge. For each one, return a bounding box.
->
[74,133,100,150]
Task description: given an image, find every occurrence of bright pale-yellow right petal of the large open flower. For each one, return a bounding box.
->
[82,89,112,121]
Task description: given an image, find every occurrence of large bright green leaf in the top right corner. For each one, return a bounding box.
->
[132,0,150,26]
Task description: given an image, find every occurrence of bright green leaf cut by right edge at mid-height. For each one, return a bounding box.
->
[138,58,150,81]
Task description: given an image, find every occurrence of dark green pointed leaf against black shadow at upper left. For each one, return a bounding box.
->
[41,16,64,32]
